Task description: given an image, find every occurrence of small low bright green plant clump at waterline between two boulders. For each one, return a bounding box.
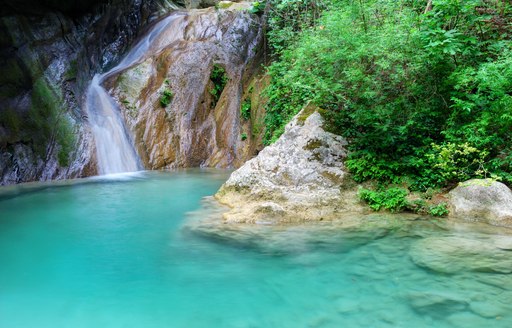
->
[359,188,408,212]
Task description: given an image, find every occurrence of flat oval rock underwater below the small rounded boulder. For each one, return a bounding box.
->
[409,237,512,273]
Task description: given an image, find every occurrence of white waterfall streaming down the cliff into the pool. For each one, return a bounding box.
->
[85,14,181,174]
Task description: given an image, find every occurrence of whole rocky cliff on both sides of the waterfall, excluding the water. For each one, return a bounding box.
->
[0,0,265,184]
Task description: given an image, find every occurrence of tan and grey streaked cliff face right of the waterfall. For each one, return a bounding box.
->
[105,3,262,169]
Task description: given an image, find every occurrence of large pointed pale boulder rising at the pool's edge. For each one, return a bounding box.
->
[215,106,361,224]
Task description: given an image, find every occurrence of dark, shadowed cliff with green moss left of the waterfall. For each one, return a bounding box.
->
[0,0,179,185]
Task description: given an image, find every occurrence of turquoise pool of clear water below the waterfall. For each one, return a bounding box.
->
[0,171,512,328]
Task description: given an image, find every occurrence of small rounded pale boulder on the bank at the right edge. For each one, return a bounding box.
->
[449,179,512,227]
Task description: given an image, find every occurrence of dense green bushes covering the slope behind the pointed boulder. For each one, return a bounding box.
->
[264,0,512,190]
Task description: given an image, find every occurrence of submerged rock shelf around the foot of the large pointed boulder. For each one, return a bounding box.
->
[183,197,419,254]
